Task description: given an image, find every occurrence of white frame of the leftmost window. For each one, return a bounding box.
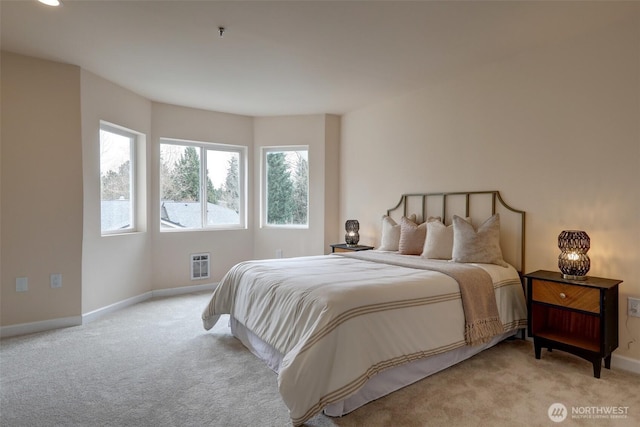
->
[98,120,138,236]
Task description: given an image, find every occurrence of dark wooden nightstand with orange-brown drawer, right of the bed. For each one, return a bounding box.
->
[524,270,622,378]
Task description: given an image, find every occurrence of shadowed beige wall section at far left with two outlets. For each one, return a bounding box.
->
[0,52,82,325]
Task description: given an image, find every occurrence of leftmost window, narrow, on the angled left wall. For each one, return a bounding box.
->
[100,122,138,234]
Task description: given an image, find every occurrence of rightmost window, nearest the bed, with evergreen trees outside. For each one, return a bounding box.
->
[262,147,309,227]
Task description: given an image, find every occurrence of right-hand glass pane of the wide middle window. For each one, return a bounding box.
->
[207,150,241,225]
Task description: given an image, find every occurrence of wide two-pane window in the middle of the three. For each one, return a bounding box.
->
[160,138,246,231]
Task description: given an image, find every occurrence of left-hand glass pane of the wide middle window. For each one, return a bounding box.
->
[160,144,202,229]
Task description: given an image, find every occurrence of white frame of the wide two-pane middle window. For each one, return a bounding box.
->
[158,137,248,233]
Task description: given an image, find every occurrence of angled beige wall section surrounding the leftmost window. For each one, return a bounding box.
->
[81,70,152,314]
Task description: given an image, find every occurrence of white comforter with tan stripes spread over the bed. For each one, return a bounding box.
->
[202,251,527,425]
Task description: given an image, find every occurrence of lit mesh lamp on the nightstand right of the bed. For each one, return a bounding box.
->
[558,230,591,280]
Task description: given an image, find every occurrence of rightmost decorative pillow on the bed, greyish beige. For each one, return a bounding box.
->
[451,214,508,267]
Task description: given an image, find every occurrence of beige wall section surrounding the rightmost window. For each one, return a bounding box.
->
[252,114,339,258]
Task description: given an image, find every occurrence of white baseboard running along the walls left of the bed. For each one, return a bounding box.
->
[0,283,217,338]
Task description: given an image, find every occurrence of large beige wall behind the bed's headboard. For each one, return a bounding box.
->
[340,14,640,360]
